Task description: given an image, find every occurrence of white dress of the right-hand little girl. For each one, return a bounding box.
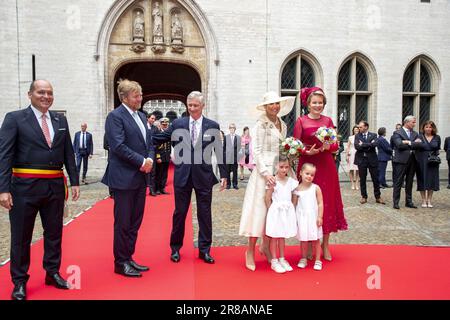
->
[294,183,323,241]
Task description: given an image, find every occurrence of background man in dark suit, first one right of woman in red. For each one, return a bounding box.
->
[355,121,385,204]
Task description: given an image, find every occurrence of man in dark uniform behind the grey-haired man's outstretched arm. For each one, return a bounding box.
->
[156,118,172,194]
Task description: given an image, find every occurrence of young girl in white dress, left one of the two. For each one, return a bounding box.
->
[266,155,298,273]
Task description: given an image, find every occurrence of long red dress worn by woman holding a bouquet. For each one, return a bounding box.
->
[294,115,347,234]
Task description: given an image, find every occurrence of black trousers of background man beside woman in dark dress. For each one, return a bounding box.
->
[392,153,416,205]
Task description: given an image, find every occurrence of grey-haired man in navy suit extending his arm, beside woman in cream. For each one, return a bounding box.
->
[154,91,227,263]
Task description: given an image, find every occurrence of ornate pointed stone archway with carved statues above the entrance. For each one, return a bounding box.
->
[95,0,219,122]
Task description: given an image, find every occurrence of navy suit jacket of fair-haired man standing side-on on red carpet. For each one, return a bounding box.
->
[102,105,156,190]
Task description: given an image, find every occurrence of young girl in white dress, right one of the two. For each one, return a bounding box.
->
[292,163,323,270]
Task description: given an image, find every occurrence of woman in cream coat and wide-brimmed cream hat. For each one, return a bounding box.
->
[239,92,295,271]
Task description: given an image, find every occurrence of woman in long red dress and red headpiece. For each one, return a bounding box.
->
[294,87,347,261]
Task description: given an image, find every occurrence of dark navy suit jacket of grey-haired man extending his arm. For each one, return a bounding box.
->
[153,117,227,189]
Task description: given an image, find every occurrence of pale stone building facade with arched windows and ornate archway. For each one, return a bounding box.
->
[0,0,450,150]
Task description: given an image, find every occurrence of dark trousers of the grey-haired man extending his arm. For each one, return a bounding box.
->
[170,179,212,253]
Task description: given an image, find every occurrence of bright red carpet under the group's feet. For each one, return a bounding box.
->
[0,168,450,300]
